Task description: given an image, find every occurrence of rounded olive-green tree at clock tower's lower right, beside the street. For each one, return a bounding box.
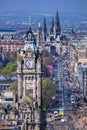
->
[42,78,56,109]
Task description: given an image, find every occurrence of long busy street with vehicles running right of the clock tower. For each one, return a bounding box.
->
[47,54,77,130]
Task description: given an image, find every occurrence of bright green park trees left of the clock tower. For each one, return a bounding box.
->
[0,52,17,77]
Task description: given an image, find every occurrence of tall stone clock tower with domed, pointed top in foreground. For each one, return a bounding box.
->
[17,27,42,130]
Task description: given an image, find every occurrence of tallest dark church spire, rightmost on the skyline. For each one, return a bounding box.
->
[55,9,61,37]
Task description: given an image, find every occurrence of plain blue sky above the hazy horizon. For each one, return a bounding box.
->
[0,0,87,14]
